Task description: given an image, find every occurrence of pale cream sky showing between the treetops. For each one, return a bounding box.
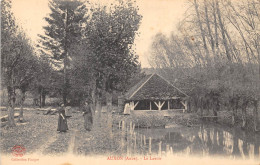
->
[12,0,188,68]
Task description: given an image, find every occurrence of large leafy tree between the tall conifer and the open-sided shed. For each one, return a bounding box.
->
[85,1,141,111]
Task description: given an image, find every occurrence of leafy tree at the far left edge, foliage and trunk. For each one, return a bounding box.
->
[1,0,35,127]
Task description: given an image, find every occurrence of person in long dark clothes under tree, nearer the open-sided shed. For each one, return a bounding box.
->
[83,101,93,131]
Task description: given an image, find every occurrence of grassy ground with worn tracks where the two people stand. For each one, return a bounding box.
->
[0,110,123,155]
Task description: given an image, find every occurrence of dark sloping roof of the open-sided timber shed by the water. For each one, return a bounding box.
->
[124,74,188,100]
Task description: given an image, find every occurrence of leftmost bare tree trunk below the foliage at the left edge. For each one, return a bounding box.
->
[7,86,15,127]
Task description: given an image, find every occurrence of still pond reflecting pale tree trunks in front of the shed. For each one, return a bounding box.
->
[119,124,260,159]
